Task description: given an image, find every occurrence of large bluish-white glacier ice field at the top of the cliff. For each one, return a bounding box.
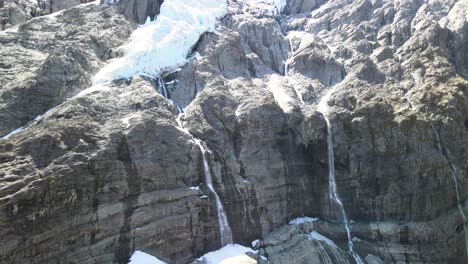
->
[93,0,227,84]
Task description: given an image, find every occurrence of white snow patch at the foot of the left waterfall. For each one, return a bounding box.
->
[199,244,257,264]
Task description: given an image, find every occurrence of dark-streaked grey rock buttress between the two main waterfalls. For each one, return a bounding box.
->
[179,74,327,243]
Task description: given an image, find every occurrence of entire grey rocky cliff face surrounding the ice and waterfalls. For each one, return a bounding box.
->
[0,0,468,264]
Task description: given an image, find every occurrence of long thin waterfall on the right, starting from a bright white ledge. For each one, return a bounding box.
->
[317,89,363,264]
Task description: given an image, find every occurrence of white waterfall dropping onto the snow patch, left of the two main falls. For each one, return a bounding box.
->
[194,139,233,246]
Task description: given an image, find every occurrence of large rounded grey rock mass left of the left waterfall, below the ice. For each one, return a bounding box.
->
[0,77,223,263]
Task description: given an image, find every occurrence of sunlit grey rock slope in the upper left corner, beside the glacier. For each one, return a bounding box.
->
[0,5,133,135]
